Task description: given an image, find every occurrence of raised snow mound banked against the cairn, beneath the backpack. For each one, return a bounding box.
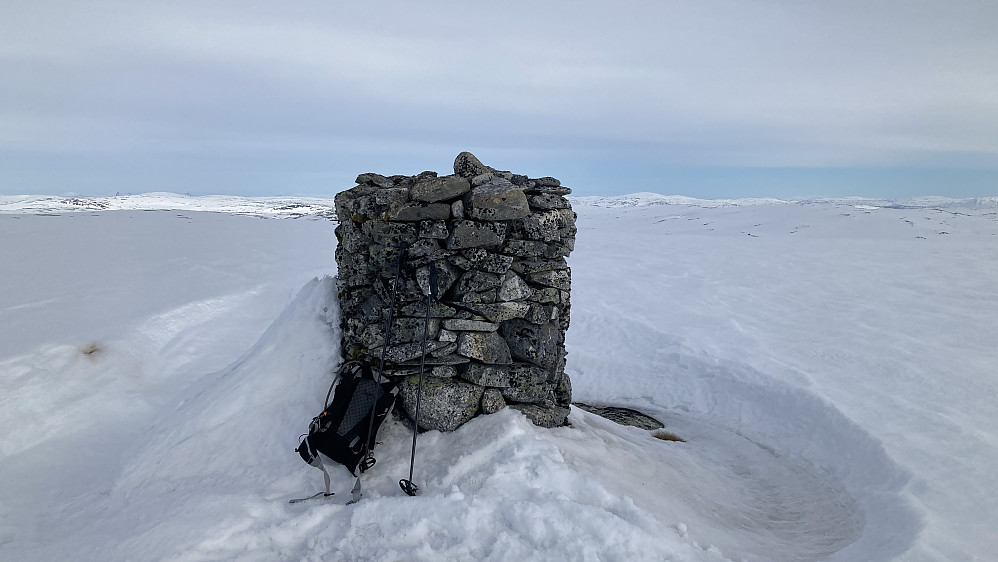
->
[15,277,724,560]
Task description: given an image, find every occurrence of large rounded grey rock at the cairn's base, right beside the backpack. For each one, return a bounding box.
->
[399,376,485,431]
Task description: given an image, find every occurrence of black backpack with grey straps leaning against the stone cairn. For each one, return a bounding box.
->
[295,361,399,495]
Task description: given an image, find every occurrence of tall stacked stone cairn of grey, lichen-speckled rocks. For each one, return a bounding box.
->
[336,152,576,431]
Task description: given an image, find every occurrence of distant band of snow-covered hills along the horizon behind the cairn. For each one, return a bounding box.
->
[0,192,998,213]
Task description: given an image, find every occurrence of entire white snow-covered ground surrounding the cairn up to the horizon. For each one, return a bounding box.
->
[0,194,998,561]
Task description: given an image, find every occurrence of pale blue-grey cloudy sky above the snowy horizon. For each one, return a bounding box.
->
[0,0,998,198]
